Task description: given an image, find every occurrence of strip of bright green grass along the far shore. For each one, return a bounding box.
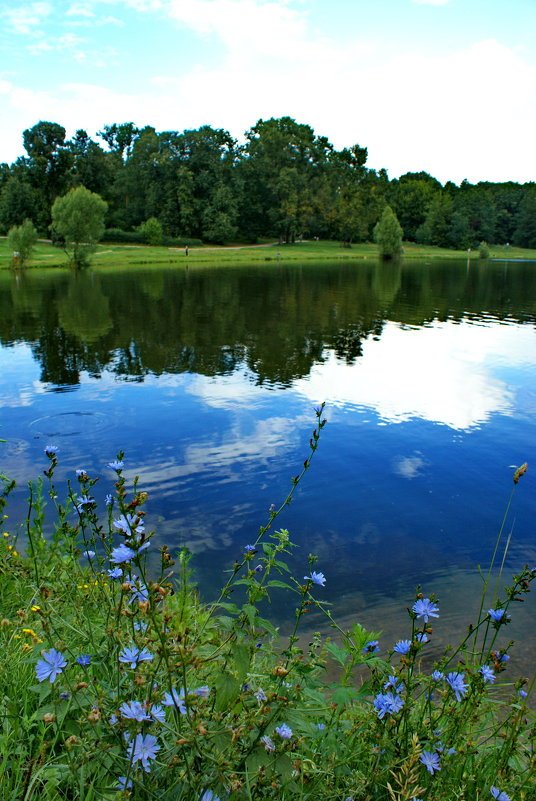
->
[0,238,536,269]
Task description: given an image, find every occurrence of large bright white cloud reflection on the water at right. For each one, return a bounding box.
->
[295,322,536,430]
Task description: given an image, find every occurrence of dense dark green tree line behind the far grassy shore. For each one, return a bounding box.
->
[0,117,536,249]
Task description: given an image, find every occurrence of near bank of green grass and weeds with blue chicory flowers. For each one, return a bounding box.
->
[0,406,536,801]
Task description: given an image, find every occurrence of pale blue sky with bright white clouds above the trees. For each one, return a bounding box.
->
[0,0,536,184]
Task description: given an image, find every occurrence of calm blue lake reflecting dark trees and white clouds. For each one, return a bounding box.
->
[0,260,536,672]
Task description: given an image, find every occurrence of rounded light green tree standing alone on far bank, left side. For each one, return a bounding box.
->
[52,186,108,267]
